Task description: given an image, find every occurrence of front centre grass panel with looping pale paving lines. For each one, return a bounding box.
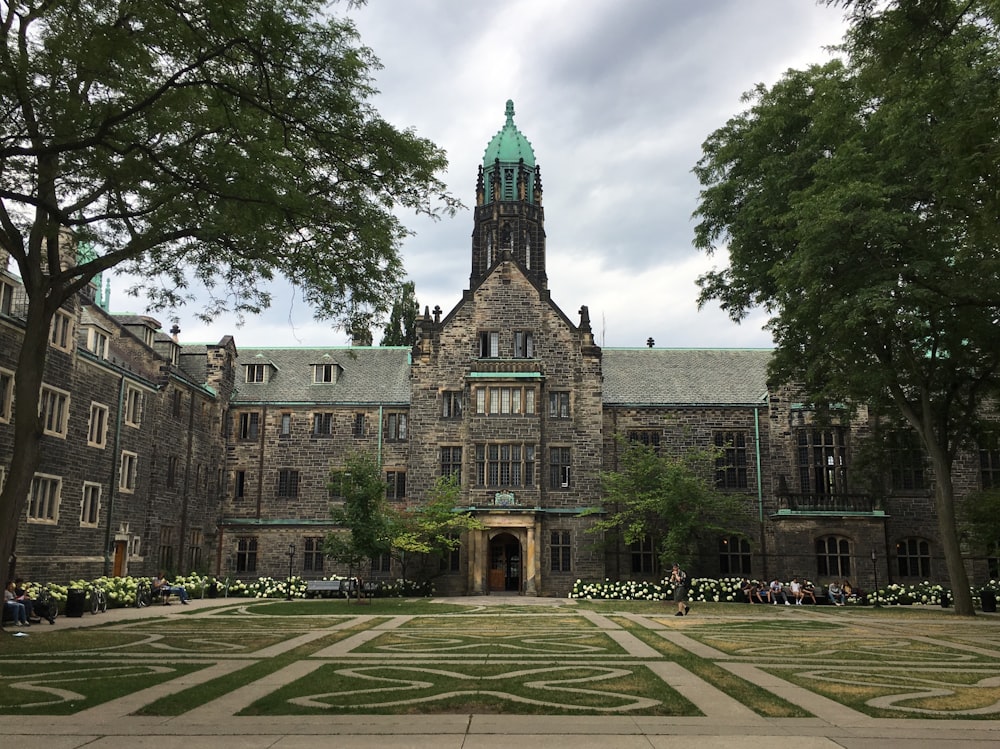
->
[239,663,701,715]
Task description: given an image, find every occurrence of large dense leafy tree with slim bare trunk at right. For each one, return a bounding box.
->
[694,0,1000,615]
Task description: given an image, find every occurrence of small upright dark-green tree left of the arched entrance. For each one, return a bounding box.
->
[323,452,397,594]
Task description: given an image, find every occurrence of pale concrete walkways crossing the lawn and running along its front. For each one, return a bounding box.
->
[0,597,1000,749]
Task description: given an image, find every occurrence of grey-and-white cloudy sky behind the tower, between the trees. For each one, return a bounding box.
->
[139,0,844,348]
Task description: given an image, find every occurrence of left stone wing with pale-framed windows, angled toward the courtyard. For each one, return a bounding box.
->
[0,247,236,582]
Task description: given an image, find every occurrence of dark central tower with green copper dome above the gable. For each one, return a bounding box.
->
[469,99,547,289]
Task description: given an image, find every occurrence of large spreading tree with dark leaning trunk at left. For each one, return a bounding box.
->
[0,0,456,580]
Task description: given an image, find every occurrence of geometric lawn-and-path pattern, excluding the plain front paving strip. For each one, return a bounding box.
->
[0,598,1000,725]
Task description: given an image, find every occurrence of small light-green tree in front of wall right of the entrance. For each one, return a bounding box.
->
[587,436,747,568]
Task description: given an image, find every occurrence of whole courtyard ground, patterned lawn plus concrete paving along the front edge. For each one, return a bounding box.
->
[0,596,1000,749]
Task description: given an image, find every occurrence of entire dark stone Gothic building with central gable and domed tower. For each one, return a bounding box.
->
[0,102,1000,596]
